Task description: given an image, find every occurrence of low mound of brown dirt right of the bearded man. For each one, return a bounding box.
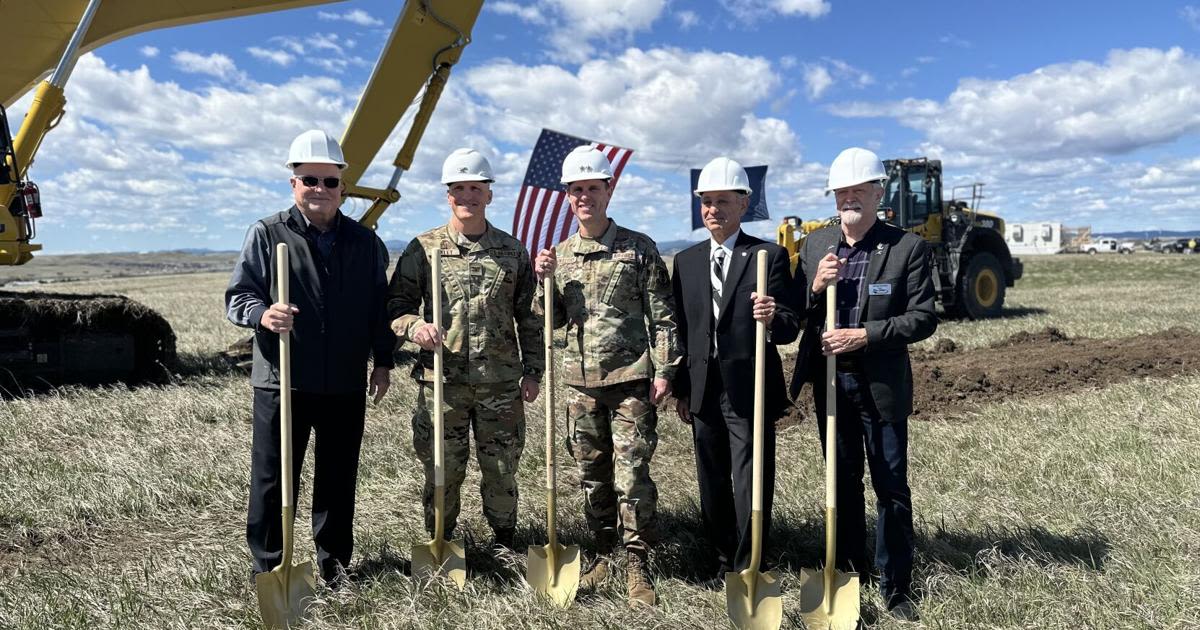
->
[912,328,1200,416]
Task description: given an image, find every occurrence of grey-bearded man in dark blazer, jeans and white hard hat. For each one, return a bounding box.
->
[792,148,937,619]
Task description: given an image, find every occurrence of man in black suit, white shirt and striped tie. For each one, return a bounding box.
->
[672,157,800,577]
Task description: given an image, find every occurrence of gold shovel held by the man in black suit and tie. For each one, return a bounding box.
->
[725,250,784,630]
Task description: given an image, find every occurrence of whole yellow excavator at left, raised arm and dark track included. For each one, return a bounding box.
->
[0,0,482,388]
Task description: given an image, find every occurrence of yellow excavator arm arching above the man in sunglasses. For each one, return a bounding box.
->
[0,0,484,265]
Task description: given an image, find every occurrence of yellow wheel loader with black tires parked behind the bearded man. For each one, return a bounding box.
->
[779,157,1024,319]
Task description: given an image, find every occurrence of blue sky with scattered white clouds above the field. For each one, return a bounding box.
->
[12,0,1200,253]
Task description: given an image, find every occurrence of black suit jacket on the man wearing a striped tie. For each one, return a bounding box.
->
[671,232,802,418]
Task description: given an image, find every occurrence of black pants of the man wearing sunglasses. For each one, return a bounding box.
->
[246,388,366,580]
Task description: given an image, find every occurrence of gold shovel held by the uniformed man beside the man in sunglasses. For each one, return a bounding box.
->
[413,248,467,588]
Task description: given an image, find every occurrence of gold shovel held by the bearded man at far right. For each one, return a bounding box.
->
[800,282,859,630]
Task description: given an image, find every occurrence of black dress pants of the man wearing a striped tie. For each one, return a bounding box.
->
[691,359,775,571]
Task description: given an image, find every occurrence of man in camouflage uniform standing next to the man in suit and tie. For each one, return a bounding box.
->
[534,146,680,606]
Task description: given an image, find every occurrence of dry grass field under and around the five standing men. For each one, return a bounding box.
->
[0,254,1200,629]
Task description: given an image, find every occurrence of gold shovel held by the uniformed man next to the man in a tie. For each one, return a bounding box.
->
[526,276,580,608]
